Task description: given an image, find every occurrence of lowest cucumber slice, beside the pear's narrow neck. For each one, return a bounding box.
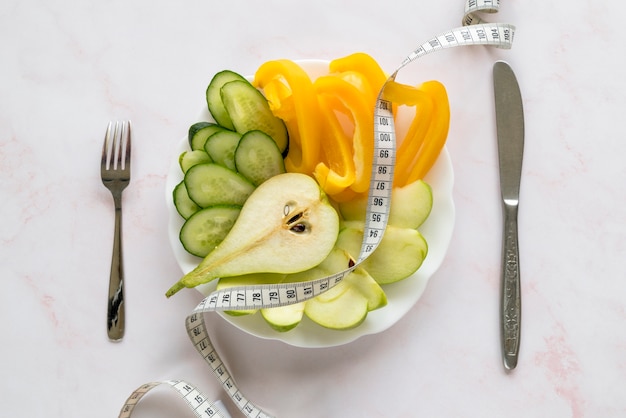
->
[179,206,241,257]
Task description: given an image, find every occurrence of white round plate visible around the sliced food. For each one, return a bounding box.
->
[166,60,455,348]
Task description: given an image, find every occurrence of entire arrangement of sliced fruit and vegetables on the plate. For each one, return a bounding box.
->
[167,53,449,332]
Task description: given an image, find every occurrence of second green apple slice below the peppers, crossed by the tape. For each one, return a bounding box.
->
[336,221,428,284]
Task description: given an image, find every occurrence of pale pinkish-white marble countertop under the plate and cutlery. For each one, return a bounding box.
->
[0,0,626,418]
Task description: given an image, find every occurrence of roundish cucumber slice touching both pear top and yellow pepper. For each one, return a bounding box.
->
[234,131,285,186]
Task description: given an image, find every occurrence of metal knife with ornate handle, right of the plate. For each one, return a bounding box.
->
[493,61,524,370]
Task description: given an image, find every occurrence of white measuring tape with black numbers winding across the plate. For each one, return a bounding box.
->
[119,0,515,418]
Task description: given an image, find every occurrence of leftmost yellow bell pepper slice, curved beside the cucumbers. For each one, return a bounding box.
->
[253,59,322,175]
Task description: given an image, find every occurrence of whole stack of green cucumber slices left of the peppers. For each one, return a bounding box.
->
[172,70,288,257]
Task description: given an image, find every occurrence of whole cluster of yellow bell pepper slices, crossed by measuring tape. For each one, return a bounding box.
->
[253,53,450,194]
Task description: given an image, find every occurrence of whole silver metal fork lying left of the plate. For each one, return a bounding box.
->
[100,122,130,341]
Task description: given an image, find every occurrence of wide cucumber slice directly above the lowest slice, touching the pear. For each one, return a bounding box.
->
[184,163,255,208]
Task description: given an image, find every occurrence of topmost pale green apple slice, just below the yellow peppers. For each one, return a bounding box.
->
[339,180,433,229]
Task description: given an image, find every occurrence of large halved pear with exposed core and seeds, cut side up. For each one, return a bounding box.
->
[166,173,339,297]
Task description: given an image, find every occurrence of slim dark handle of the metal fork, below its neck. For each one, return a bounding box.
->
[107,202,126,341]
